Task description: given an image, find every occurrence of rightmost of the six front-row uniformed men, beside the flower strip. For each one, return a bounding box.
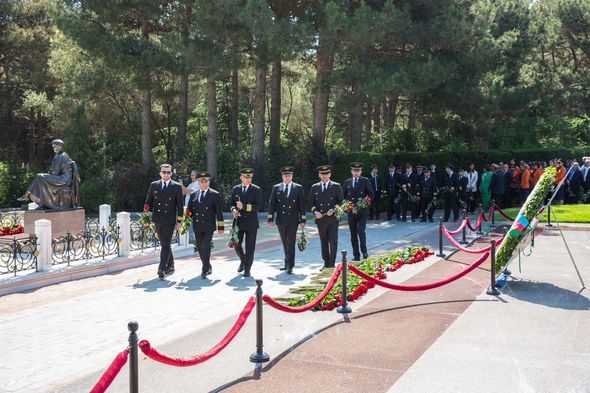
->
[344,162,373,261]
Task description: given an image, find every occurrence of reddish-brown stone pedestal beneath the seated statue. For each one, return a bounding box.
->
[24,207,86,238]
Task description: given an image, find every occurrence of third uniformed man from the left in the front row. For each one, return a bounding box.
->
[231,168,262,277]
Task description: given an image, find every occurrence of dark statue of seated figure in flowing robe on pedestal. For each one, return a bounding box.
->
[18,139,80,209]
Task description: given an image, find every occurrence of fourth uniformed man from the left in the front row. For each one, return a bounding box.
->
[268,166,306,274]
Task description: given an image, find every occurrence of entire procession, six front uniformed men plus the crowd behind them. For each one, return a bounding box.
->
[145,157,590,279]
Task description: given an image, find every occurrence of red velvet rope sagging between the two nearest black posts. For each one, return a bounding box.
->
[139,296,256,367]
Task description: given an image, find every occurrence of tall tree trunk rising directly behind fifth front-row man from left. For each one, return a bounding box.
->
[313,32,334,149]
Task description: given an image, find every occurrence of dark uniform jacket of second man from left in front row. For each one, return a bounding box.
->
[187,188,224,232]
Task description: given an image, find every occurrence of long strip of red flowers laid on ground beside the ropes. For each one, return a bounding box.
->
[289,247,434,311]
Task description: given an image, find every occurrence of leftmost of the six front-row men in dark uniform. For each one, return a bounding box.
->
[145,164,184,278]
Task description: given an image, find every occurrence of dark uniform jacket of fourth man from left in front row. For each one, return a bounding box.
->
[268,182,306,225]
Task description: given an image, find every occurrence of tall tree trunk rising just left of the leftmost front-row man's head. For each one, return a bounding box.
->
[141,17,155,167]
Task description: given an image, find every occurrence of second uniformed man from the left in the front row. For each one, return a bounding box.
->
[187,172,224,278]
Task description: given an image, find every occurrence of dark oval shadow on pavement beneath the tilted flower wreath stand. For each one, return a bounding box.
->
[506,280,590,310]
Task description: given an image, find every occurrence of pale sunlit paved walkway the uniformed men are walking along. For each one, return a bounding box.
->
[0,213,468,392]
